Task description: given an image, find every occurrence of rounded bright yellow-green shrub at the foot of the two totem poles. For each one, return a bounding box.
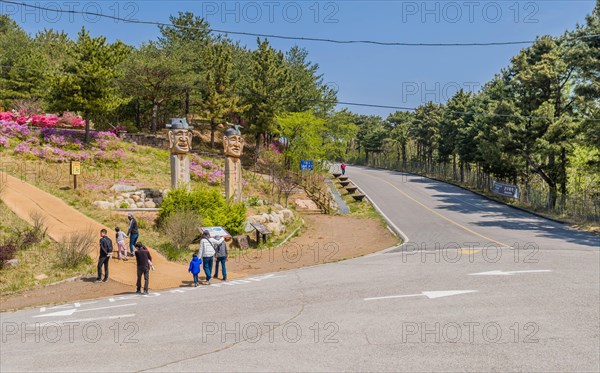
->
[158,186,246,235]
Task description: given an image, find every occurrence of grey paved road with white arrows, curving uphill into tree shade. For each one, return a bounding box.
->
[0,168,600,372]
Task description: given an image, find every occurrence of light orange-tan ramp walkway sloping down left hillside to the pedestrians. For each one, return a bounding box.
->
[0,172,192,290]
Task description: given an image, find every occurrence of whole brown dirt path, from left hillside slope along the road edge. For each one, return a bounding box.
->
[0,174,398,311]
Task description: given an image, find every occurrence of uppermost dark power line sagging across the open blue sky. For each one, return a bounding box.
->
[0,0,600,47]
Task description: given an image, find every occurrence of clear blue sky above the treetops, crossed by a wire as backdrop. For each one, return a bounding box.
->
[0,0,595,116]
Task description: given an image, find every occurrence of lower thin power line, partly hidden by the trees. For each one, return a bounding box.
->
[0,65,600,122]
